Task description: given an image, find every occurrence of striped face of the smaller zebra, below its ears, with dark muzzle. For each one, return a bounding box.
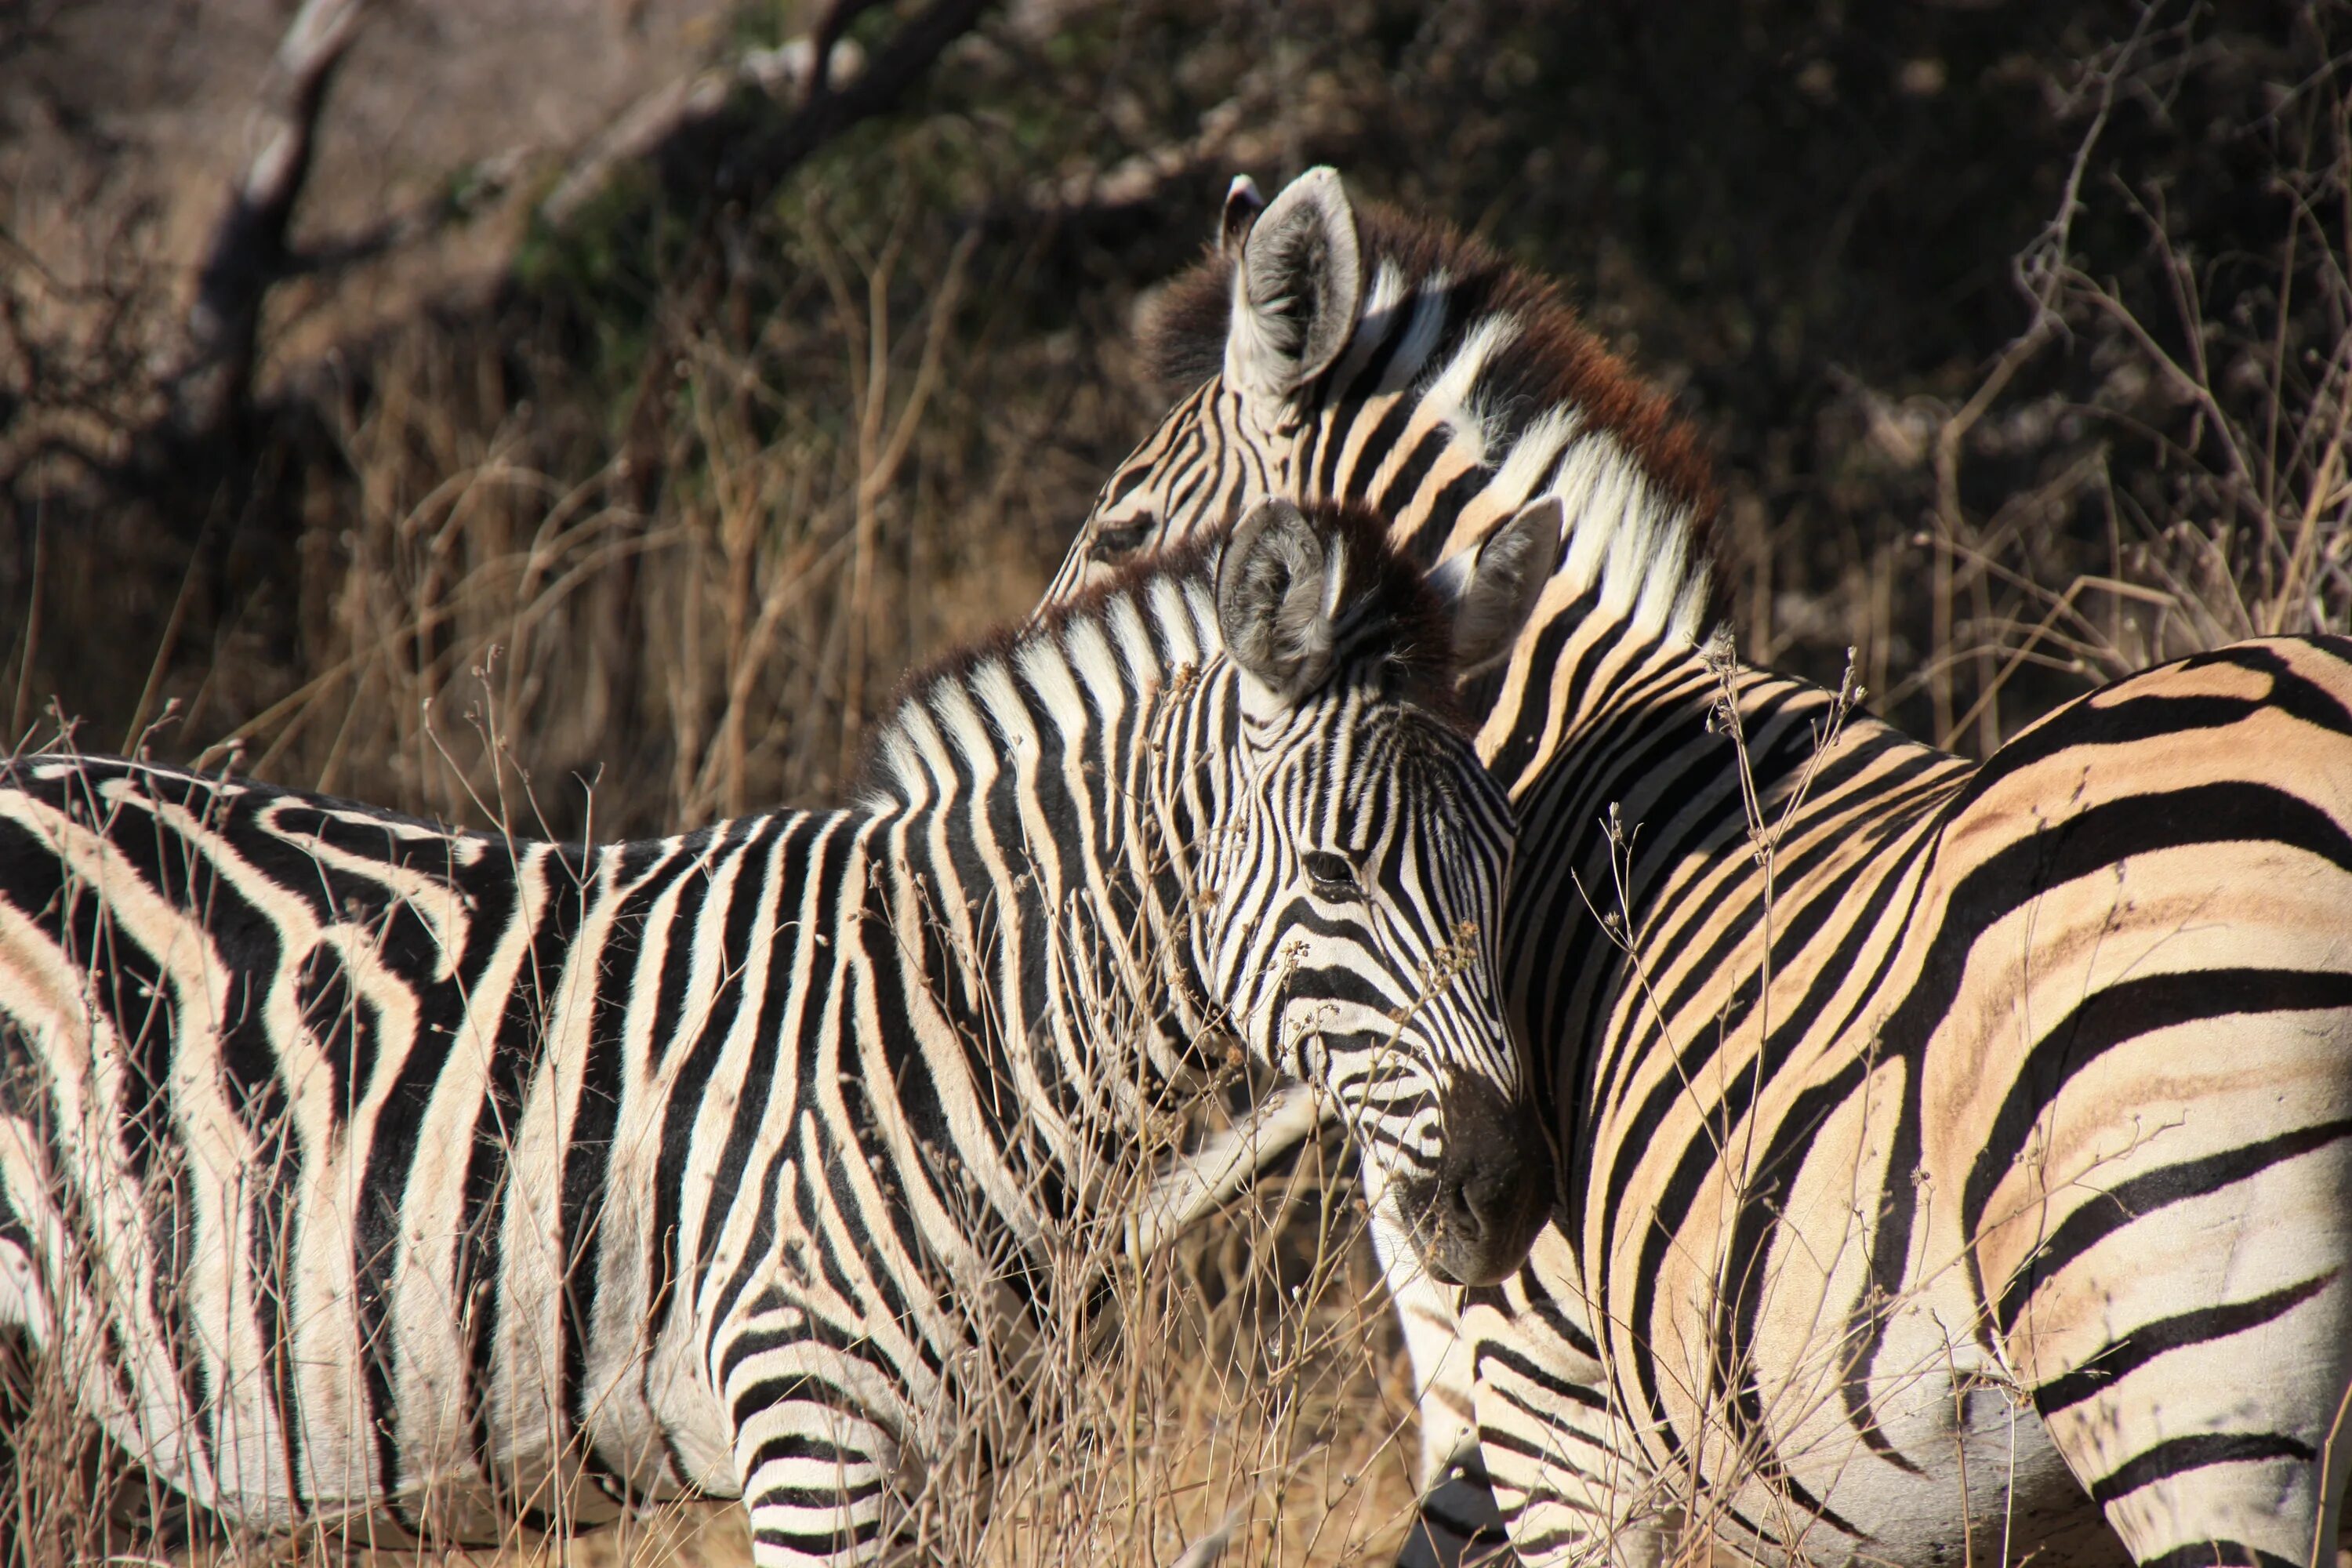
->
[1223,710,1552,1283]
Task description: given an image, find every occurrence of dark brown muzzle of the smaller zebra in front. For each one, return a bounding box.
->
[1390,1079,1552,1286]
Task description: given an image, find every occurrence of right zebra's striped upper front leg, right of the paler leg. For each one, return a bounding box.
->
[1463,1227,1675,1568]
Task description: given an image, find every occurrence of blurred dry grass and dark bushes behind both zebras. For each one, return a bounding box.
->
[0,0,2352,832]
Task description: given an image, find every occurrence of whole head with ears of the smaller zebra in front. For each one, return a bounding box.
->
[1188,501,1559,1283]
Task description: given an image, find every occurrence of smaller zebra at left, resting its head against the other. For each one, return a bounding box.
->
[0,501,1559,1568]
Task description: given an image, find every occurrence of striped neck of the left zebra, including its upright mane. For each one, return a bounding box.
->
[863,576,1240,1220]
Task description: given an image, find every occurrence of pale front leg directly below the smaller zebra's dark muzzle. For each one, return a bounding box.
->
[1371,1225,1510,1568]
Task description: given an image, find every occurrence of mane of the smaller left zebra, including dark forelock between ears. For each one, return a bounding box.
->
[854,501,1468,799]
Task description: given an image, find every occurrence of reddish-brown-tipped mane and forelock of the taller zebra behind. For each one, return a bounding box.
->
[1143,191,1719,637]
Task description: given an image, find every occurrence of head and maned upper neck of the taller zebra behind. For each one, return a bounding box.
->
[1047,169,1715,635]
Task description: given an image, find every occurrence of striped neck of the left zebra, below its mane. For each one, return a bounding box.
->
[870,658,1230,1222]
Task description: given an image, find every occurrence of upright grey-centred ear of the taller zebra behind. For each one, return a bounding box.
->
[1218,169,1364,400]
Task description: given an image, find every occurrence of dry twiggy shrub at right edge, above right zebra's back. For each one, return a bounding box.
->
[1733,0,2352,757]
